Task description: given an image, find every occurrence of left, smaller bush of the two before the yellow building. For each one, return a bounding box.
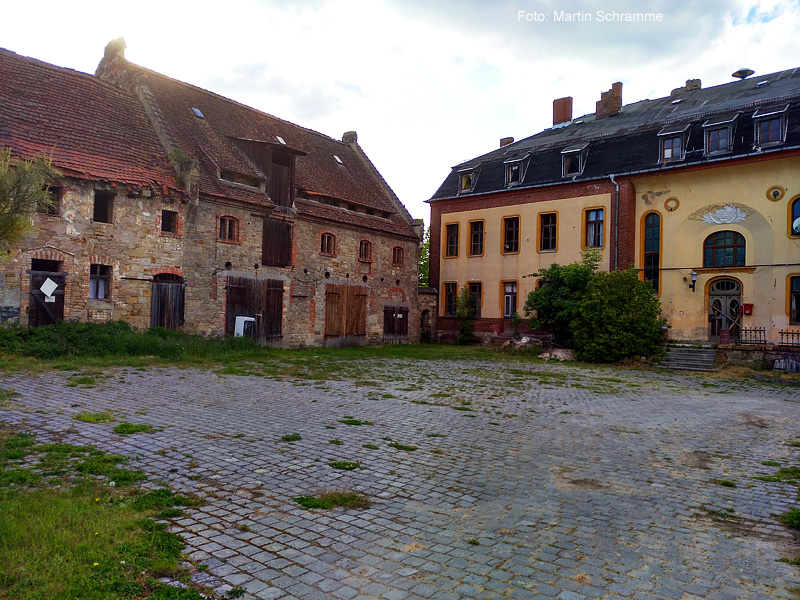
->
[524,250,600,347]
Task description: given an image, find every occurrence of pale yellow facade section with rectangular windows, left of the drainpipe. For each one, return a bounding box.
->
[440,194,611,319]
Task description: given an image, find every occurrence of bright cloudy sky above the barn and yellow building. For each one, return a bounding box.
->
[0,0,800,221]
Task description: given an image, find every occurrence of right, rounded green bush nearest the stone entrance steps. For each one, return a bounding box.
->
[572,267,666,362]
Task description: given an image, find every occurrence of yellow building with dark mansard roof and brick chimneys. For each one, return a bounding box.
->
[429,69,800,343]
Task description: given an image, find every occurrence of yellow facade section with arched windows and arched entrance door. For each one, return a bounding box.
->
[633,156,800,342]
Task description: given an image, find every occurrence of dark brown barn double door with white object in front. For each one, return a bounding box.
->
[225,276,283,346]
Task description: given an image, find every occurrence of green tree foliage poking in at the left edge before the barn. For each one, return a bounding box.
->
[0,148,60,256]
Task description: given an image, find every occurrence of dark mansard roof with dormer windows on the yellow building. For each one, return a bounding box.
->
[431,68,800,200]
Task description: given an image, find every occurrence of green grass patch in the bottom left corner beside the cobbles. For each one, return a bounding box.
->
[0,429,206,600]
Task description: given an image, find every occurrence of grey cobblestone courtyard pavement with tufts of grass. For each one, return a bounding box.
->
[0,360,800,600]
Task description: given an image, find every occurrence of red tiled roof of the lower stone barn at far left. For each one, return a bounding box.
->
[0,49,177,189]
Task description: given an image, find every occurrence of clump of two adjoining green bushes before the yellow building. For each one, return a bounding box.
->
[525,250,665,362]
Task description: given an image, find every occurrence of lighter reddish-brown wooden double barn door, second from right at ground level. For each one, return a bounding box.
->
[325,283,368,348]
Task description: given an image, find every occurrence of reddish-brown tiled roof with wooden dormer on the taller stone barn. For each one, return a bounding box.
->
[98,52,414,235]
